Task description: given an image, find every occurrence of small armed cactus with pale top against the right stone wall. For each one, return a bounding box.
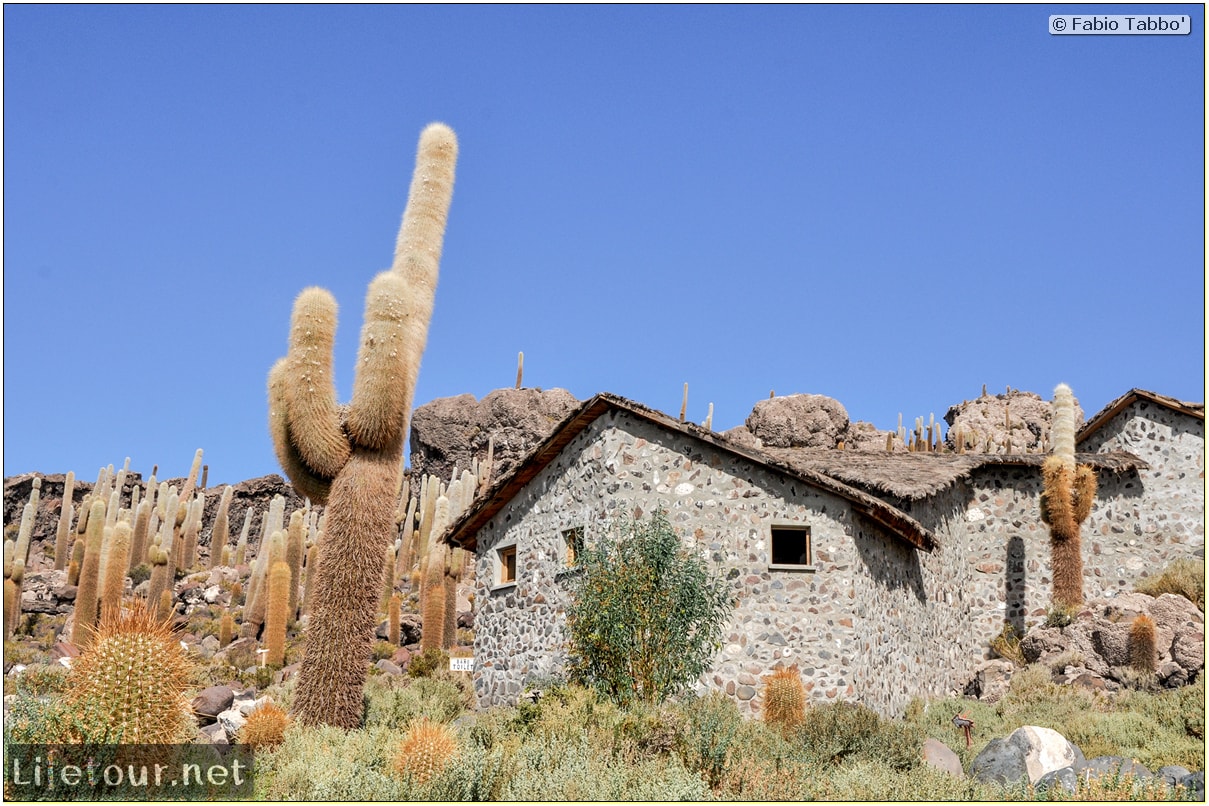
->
[1041,383,1097,608]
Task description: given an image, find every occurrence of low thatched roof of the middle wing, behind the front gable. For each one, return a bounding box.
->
[760,448,1147,500]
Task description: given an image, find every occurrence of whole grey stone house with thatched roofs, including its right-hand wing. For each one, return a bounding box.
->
[446,390,1204,714]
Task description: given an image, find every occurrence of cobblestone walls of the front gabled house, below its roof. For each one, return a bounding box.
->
[466,412,980,713]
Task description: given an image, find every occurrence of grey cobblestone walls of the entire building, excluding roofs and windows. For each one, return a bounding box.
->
[475,403,1204,714]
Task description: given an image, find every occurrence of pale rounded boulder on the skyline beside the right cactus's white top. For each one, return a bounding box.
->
[944,389,1083,453]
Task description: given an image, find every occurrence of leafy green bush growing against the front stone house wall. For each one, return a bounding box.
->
[567,510,734,702]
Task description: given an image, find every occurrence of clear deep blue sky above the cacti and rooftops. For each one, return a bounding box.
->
[4,5,1205,485]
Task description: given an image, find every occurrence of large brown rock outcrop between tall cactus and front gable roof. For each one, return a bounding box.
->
[411,389,579,479]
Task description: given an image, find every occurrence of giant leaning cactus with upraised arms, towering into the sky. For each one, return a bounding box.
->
[268,123,457,729]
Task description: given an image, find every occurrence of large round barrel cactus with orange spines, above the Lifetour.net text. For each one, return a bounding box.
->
[65,603,193,744]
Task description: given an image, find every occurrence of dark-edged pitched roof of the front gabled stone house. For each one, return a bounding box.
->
[445,394,936,551]
